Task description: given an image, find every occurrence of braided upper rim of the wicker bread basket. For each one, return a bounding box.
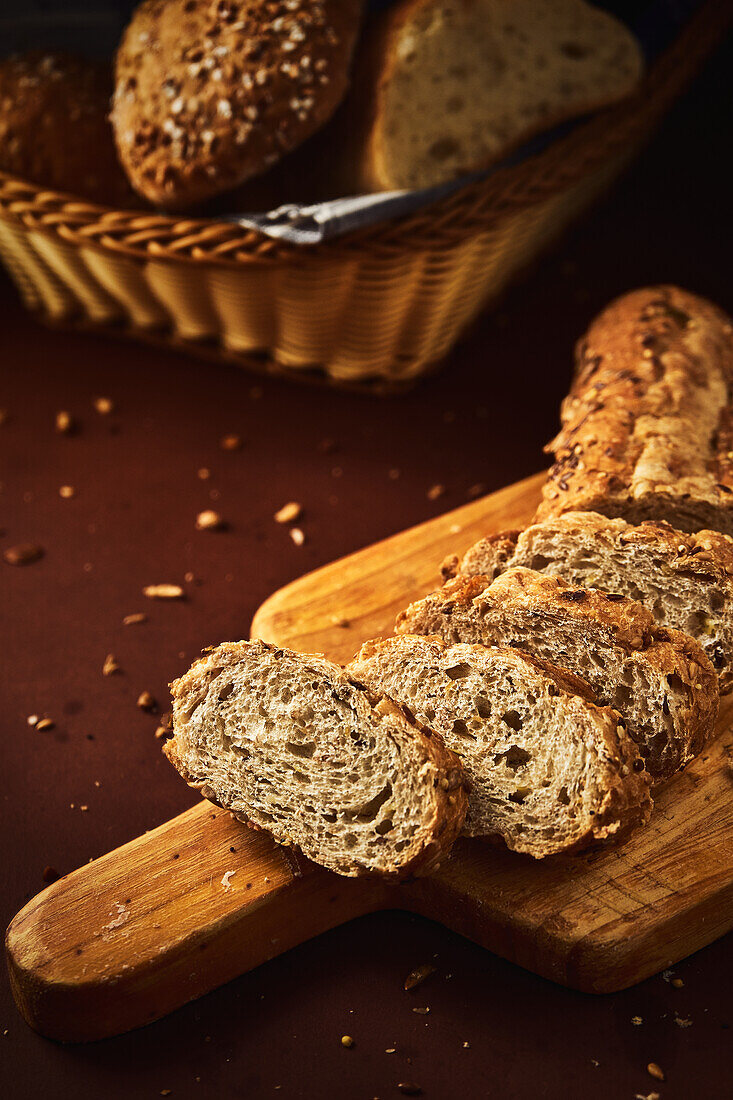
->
[0,0,733,265]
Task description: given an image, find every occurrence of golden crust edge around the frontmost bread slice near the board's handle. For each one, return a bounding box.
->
[163,640,468,881]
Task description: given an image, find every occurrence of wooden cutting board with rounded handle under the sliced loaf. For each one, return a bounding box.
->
[7,475,733,1041]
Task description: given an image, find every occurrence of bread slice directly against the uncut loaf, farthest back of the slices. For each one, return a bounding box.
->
[441,512,733,694]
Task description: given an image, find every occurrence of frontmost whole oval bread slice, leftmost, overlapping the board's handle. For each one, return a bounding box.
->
[165,641,468,878]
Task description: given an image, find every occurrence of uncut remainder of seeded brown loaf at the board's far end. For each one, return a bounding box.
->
[536,286,733,535]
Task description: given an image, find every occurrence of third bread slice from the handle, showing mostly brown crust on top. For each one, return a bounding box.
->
[396,569,719,780]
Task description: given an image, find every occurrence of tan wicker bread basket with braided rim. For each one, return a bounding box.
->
[0,0,732,388]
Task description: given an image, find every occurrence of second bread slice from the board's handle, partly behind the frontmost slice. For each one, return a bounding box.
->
[349,635,652,859]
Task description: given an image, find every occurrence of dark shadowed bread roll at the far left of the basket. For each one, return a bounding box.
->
[0,51,140,207]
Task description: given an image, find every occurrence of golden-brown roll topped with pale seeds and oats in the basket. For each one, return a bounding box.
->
[112,0,362,210]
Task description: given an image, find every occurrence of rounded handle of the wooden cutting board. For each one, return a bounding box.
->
[6,802,384,1042]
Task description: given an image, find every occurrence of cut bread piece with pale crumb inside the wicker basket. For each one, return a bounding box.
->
[344,0,643,191]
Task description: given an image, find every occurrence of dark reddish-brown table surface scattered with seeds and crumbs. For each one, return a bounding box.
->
[0,34,733,1100]
